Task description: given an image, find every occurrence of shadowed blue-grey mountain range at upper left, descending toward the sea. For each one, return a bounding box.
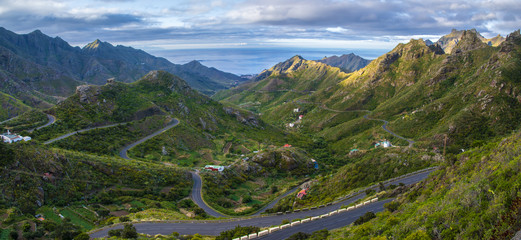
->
[0,28,243,108]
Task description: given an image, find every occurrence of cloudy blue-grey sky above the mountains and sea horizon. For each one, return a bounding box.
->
[0,0,521,72]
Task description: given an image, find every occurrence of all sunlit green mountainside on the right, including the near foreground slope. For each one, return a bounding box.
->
[214,30,521,239]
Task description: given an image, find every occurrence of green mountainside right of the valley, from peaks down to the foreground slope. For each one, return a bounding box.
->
[209,31,521,223]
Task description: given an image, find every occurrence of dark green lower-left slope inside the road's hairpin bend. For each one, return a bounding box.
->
[0,142,192,239]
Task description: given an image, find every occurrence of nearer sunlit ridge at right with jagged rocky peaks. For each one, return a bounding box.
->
[327,31,519,152]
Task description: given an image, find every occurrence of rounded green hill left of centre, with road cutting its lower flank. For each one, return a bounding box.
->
[34,71,286,166]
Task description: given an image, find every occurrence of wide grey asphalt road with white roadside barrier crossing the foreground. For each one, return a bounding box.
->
[90,170,434,239]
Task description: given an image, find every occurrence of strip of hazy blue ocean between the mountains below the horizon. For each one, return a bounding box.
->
[150,48,391,75]
